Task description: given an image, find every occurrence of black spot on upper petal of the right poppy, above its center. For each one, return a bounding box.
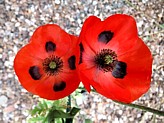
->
[98,31,114,44]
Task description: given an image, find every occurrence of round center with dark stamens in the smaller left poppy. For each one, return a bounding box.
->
[42,55,63,76]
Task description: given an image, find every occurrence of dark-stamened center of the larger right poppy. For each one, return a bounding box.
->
[94,49,117,72]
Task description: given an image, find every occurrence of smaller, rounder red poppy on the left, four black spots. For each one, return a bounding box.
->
[14,24,80,100]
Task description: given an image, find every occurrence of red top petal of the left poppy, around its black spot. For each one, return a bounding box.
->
[30,24,72,56]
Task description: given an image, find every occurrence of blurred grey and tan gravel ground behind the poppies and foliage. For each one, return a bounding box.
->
[0,0,164,123]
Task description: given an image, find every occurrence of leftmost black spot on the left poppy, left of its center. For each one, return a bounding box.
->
[29,66,42,80]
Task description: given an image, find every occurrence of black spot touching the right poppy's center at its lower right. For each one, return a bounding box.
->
[112,61,127,79]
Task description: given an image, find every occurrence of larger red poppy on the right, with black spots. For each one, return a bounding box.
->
[78,14,152,103]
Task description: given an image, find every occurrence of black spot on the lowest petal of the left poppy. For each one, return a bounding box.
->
[53,81,66,92]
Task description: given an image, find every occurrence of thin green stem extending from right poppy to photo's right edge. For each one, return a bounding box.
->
[114,101,164,116]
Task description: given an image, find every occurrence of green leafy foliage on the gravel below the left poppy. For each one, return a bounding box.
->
[28,98,80,123]
